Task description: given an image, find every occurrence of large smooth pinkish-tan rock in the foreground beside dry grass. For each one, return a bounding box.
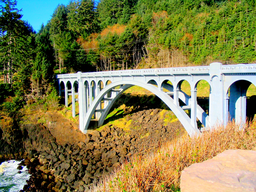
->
[180,150,256,192]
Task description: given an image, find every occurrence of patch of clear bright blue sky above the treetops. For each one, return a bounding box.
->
[17,0,70,32]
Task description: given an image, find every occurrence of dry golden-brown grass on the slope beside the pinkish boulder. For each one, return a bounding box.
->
[92,122,256,191]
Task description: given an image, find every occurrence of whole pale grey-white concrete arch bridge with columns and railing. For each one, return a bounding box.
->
[57,63,256,136]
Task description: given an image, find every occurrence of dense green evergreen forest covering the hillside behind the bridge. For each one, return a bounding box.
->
[0,0,256,99]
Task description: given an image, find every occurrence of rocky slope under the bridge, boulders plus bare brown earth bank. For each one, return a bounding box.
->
[1,94,184,191]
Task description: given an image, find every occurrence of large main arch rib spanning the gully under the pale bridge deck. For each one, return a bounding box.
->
[82,80,200,136]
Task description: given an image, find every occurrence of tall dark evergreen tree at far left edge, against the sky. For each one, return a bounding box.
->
[0,0,33,84]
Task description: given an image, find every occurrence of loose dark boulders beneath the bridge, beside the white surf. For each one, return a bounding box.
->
[1,109,185,191]
